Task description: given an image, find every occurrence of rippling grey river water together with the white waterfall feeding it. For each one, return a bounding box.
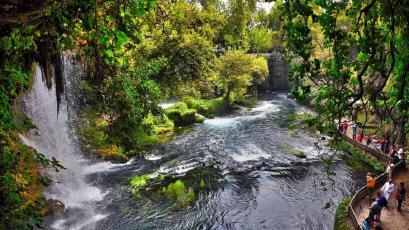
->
[21,61,364,230]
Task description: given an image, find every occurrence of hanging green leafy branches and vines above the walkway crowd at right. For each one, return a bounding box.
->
[282,0,409,145]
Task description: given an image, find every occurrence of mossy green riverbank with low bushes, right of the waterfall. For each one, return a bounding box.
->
[77,97,241,162]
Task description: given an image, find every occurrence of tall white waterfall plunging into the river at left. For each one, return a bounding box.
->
[20,55,104,229]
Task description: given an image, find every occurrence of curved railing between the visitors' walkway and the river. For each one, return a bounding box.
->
[342,135,406,229]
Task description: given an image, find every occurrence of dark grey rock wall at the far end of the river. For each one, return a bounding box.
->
[259,52,291,91]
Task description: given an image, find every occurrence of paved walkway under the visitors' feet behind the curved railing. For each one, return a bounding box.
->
[347,119,409,230]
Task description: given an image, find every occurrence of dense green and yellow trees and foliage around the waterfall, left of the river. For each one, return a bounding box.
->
[0,0,282,229]
